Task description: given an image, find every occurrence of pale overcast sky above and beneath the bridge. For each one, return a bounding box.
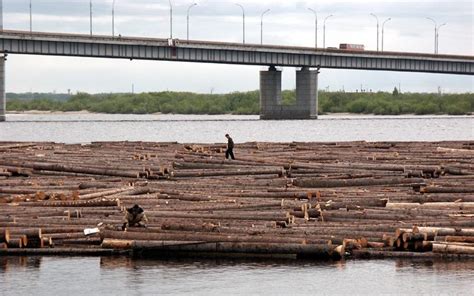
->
[3,0,474,93]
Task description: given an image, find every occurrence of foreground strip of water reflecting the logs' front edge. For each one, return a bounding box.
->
[0,257,474,296]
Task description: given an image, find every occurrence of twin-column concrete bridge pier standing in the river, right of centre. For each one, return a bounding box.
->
[260,66,319,120]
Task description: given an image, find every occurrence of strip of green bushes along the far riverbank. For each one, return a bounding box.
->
[7,89,474,115]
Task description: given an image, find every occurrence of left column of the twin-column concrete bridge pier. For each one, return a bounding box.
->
[260,66,281,119]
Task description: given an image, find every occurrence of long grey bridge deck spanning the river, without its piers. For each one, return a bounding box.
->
[0,30,474,75]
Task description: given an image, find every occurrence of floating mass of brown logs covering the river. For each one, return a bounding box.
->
[0,142,474,258]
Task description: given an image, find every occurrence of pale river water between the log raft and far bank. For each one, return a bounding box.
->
[0,114,474,143]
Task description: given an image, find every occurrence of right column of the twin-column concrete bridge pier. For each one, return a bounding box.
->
[296,67,319,119]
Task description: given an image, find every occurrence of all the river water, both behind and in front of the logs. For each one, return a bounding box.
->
[0,114,474,295]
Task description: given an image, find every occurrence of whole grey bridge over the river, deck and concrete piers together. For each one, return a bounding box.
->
[0,30,474,121]
